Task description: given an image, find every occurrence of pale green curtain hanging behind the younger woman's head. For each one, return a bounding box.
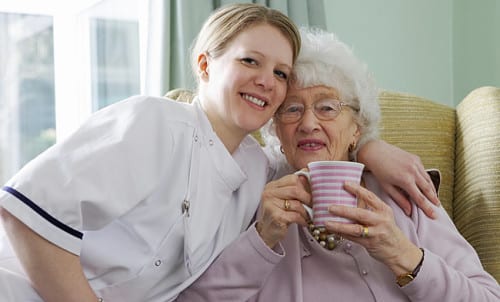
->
[143,0,326,95]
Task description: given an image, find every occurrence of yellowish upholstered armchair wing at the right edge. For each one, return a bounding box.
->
[453,87,500,280]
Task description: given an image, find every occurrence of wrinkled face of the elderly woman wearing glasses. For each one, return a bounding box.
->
[275,86,360,169]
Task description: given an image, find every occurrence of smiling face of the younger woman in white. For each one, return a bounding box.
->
[198,24,293,147]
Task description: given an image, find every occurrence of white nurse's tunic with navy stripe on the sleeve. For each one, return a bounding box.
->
[0,96,268,302]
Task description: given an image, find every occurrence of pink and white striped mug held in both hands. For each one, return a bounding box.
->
[295,161,365,226]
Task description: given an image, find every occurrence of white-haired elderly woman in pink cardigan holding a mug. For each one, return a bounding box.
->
[179,30,500,302]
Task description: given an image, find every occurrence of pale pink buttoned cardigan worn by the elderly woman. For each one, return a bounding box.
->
[177,173,500,302]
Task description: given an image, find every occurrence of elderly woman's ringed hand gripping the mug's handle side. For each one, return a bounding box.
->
[256,174,312,248]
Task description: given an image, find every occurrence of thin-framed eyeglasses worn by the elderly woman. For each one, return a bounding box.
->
[276,99,359,124]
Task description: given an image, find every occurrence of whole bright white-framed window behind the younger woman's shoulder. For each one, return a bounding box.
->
[0,0,140,183]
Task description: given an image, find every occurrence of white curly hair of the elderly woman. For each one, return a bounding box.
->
[262,27,380,165]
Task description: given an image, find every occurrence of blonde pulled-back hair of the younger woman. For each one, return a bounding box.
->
[191,3,301,79]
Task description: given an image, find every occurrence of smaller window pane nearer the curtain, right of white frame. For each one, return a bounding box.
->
[90,18,140,110]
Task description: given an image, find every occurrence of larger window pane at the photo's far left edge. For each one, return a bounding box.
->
[0,13,55,183]
